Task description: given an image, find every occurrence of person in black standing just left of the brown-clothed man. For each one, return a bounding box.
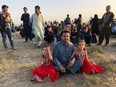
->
[90,14,99,35]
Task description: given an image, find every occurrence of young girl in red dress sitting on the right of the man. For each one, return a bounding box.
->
[72,40,104,74]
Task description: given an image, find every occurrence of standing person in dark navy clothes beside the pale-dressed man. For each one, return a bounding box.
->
[21,7,32,42]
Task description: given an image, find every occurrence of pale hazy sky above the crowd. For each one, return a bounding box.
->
[0,0,116,25]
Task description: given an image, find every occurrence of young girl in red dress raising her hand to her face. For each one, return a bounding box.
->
[31,45,59,82]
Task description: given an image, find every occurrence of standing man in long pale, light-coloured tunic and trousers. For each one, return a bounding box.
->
[31,5,44,48]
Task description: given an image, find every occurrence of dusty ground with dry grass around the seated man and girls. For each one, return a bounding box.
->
[0,36,116,87]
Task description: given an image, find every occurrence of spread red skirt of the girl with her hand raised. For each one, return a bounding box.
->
[32,60,59,82]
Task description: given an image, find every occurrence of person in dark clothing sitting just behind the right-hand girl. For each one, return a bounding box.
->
[81,25,92,46]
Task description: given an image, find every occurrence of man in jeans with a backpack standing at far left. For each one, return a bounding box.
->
[0,5,15,50]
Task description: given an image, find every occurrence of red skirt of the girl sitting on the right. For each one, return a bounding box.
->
[75,55,104,74]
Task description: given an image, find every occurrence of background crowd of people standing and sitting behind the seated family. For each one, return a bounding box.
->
[0,5,114,49]
